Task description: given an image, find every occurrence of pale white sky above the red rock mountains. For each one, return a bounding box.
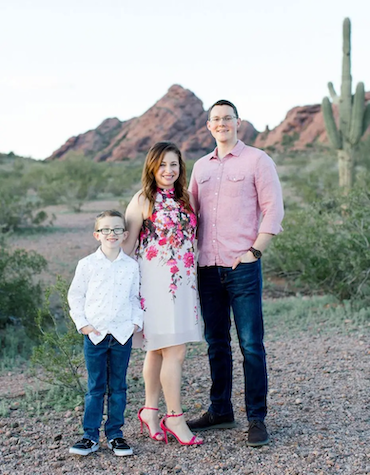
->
[0,0,370,159]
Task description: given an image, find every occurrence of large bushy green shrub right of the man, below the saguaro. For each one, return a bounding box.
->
[265,189,370,306]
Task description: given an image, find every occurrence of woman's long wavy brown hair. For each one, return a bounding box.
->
[141,142,192,213]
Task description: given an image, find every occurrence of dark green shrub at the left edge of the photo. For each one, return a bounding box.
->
[0,240,47,339]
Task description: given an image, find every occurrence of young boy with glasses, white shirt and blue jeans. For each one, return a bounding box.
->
[68,210,142,456]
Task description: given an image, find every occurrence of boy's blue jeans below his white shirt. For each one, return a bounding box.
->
[83,335,132,442]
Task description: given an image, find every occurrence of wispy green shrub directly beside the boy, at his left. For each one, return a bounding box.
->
[31,277,85,395]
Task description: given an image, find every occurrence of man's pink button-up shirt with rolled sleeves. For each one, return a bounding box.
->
[189,140,284,267]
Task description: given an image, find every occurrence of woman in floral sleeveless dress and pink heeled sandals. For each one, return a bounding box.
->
[125,142,203,445]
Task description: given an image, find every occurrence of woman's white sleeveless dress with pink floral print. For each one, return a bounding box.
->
[134,188,202,351]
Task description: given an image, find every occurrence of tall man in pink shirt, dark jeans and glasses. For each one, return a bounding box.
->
[188,100,284,447]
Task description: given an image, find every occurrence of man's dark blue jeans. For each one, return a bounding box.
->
[198,260,267,420]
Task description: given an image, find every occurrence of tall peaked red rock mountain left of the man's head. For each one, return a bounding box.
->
[49,85,257,161]
